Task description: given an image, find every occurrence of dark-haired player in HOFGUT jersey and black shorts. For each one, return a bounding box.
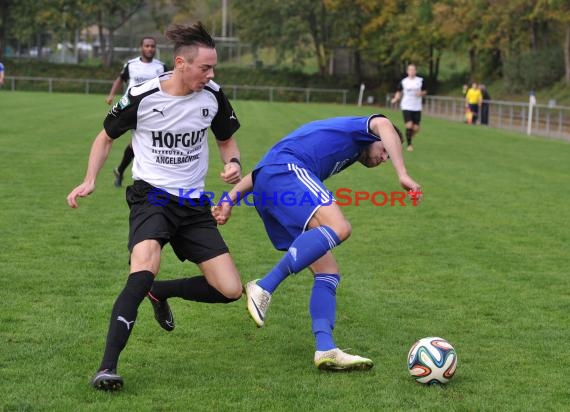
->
[67,23,242,390]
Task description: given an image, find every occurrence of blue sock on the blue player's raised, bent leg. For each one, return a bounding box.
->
[257,226,340,293]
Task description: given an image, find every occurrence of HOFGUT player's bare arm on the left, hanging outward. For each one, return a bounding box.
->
[67,129,113,209]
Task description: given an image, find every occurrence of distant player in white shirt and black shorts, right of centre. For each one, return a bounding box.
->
[392,64,427,152]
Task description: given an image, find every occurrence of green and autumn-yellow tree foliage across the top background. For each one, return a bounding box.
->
[0,0,570,90]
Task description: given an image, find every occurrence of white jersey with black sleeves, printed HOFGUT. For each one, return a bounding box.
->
[104,72,240,197]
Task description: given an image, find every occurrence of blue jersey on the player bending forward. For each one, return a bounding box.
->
[254,114,383,181]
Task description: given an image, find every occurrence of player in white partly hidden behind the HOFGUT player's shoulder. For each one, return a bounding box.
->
[105,36,168,187]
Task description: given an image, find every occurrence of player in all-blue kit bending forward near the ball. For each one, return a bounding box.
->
[212,114,421,370]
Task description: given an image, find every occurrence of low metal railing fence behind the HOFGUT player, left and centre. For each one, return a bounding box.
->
[4,76,349,104]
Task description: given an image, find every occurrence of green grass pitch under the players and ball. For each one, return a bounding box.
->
[0,91,570,411]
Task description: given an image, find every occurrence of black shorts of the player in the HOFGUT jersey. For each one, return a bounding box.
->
[126,180,229,264]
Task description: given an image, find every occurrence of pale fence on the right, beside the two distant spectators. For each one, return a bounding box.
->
[386,95,570,140]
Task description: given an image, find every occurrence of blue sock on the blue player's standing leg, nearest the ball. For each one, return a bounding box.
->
[309,273,340,351]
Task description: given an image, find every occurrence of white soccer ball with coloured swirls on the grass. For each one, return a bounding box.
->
[408,337,457,385]
